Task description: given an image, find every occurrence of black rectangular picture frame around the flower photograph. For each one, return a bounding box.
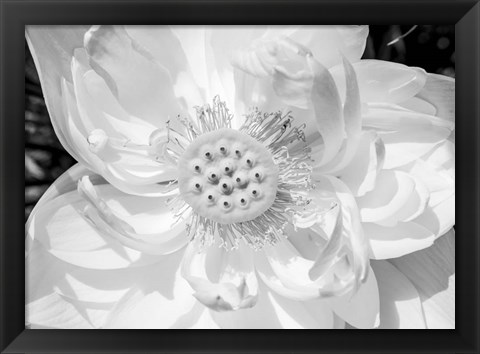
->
[0,0,480,353]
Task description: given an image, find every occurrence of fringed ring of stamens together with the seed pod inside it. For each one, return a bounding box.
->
[163,97,312,250]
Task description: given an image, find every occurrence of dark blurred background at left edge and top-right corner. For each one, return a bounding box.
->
[25,25,455,221]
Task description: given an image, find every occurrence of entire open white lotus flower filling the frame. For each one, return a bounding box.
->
[26,26,455,328]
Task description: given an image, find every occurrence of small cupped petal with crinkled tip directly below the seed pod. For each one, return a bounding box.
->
[182,241,258,311]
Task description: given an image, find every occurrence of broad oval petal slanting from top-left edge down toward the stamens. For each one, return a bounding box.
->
[85,26,182,127]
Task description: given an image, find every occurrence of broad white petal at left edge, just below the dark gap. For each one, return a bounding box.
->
[27,166,187,269]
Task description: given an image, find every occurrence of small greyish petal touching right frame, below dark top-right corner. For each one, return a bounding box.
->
[417,74,455,121]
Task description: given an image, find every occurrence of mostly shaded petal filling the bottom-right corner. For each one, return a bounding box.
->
[390,229,455,329]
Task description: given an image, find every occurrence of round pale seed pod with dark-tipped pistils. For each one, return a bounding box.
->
[178,128,278,224]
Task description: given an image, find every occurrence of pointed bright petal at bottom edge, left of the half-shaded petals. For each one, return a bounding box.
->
[329,268,380,328]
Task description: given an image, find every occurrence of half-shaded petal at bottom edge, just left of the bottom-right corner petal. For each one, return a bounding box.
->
[372,261,425,329]
